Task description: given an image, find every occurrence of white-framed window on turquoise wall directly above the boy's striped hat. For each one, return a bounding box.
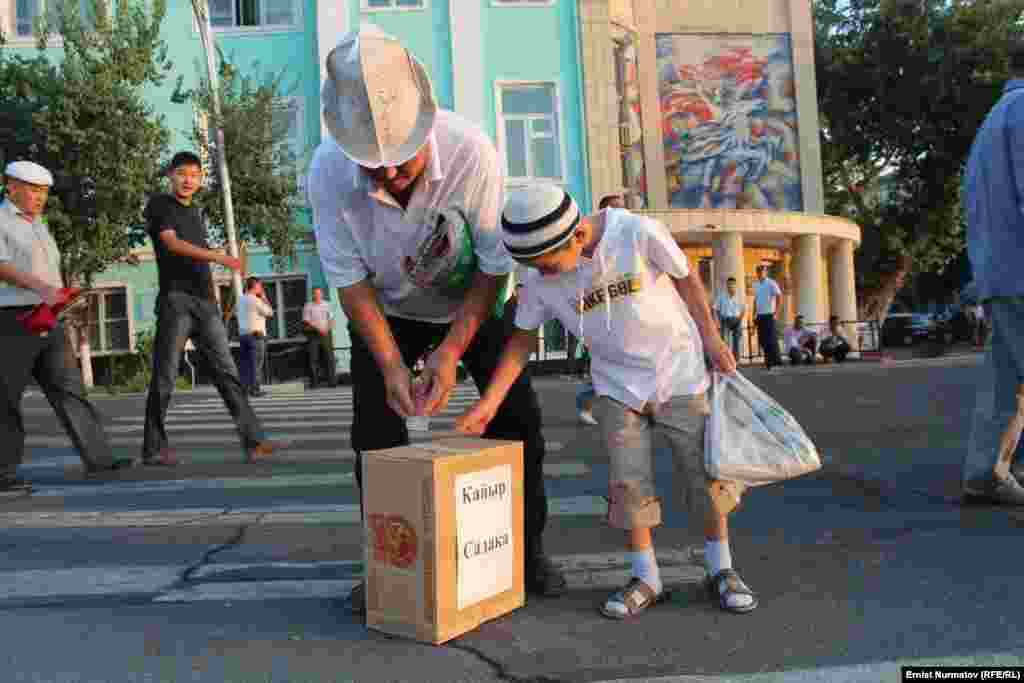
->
[498,83,565,182]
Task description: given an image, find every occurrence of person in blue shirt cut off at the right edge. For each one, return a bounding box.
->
[962,38,1024,505]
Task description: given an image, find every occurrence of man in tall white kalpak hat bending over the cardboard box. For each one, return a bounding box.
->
[308,25,566,612]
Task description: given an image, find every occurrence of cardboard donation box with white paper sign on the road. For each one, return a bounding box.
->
[362,438,525,644]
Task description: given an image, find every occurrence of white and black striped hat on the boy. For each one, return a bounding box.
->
[502,184,581,259]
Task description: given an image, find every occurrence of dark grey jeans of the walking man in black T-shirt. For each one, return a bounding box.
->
[142,292,265,458]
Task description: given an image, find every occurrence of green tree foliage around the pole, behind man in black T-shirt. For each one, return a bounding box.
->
[173,54,305,268]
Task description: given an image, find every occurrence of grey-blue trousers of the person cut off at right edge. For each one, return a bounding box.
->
[964,299,1024,488]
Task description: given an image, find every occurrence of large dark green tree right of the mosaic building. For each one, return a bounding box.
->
[813,0,1024,318]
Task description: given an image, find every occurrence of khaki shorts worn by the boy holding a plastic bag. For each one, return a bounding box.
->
[594,393,743,530]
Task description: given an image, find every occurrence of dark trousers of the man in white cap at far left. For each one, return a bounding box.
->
[0,308,113,475]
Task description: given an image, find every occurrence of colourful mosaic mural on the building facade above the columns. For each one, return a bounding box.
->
[656,34,803,211]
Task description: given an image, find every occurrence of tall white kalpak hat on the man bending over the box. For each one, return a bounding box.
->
[321,24,437,168]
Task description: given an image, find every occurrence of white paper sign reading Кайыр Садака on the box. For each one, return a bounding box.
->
[455,465,515,609]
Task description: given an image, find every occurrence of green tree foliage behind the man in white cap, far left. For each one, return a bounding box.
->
[0,0,171,287]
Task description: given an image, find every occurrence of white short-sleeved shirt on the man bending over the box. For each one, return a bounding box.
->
[307,110,515,323]
